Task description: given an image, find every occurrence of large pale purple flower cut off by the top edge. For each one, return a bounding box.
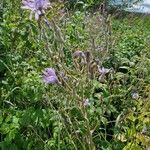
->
[21,0,50,20]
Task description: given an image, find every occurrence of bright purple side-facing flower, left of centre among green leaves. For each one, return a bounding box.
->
[43,68,58,84]
